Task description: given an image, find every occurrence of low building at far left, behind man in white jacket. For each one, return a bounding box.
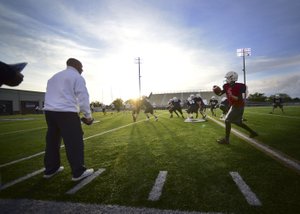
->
[0,88,45,115]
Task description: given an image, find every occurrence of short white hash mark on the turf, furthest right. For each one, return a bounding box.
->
[229,172,262,206]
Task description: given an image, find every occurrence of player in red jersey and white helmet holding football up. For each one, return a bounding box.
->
[217,71,258,144]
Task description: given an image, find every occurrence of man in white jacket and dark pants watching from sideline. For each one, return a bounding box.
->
[44,58,94,181]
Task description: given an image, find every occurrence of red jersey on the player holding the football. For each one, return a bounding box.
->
[223,83,246,107]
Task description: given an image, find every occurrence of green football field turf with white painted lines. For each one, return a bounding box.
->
[0,106,300,213]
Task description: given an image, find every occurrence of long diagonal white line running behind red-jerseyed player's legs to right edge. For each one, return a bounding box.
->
[209,116,300,173]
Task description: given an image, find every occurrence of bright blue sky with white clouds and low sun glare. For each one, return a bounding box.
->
[0,0,300,104]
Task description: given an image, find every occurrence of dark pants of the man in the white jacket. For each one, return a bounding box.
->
[44,111,86,178]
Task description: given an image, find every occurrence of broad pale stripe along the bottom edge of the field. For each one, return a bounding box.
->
[0,199,222,214]
